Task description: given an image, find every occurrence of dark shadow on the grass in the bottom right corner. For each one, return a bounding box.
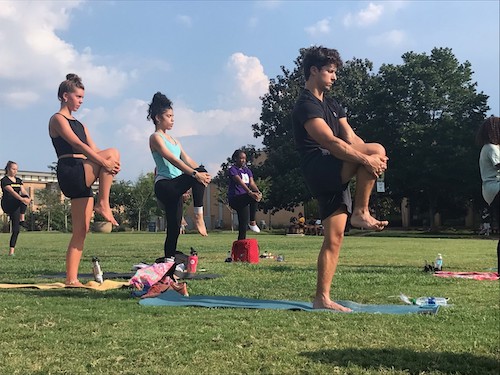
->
[301,348,500,375]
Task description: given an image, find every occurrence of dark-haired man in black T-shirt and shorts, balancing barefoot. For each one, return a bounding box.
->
[292,46,388,311]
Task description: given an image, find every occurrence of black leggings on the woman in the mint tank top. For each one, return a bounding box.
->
[155,167,206,257]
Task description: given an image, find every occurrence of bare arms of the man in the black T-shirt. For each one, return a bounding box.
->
[304,117,387,175]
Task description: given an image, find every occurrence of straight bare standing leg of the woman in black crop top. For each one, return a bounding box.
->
[65,198,94,287]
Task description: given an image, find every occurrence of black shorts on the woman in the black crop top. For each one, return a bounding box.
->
[57,158,94,199]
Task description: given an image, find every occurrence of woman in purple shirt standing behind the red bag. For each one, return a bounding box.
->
[227,150,262,240]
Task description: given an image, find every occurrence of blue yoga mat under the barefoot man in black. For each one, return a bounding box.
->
[139,290,439,314]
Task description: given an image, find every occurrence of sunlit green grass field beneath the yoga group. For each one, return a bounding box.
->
[0,232,500,375]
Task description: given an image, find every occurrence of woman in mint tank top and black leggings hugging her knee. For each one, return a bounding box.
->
[147,92,211,261]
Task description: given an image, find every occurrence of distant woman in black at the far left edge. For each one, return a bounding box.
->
[1,160,31,256]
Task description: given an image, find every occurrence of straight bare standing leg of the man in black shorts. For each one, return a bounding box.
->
[313,209,351,312]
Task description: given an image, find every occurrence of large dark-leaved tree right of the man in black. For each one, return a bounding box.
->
[355,48,489,223]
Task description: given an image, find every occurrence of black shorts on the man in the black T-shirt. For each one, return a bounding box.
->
[302,155,352,220]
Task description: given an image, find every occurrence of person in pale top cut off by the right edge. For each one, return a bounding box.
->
[476,116,500,273]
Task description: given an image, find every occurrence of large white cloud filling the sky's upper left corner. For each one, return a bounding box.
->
[0,0,129,106]
